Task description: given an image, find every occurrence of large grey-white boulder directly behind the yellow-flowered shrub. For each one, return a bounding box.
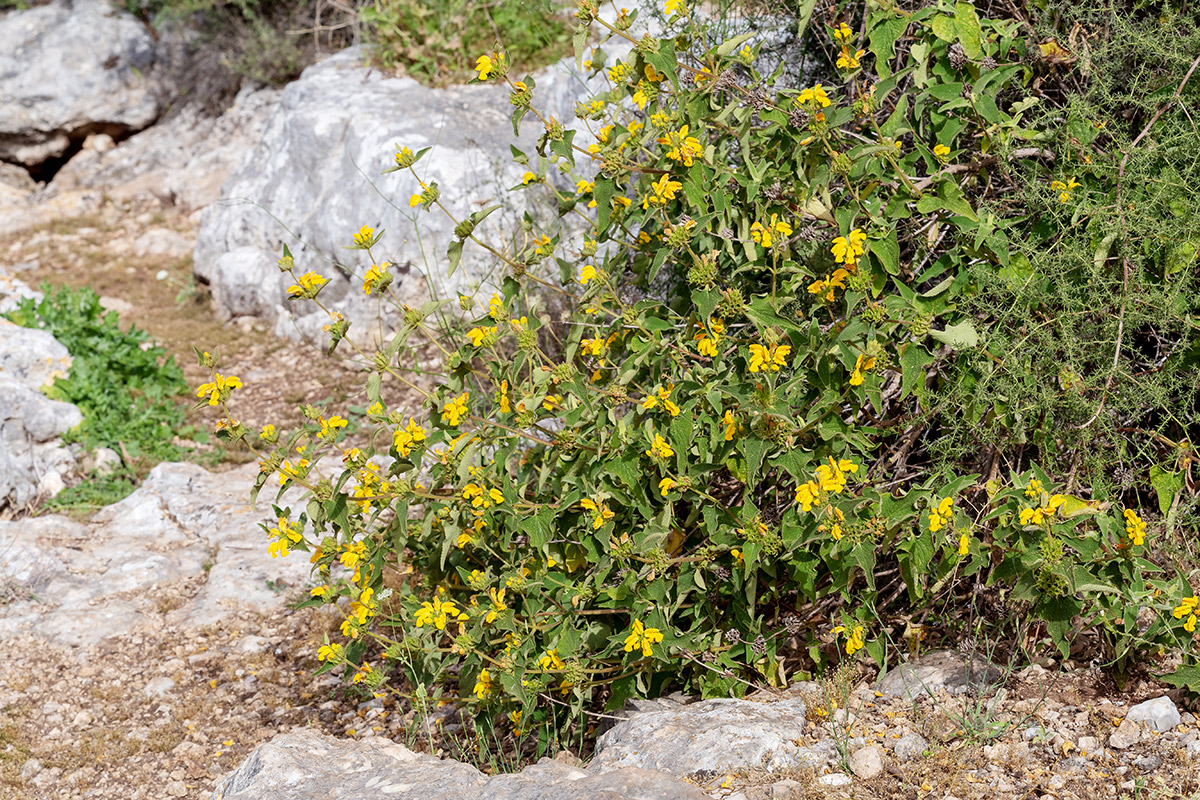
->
[193,48,600,338]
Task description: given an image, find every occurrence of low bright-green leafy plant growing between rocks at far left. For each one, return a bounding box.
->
[5,284,208,509]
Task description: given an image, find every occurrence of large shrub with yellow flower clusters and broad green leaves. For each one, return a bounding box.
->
[202,0,1196,734]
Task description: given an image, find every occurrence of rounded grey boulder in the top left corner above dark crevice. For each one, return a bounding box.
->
[0,0,160,167]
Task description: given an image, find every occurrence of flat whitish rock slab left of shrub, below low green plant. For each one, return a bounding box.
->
[0,460,310,646]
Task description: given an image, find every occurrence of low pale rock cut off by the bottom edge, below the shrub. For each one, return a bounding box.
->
[212,730,708,800]
